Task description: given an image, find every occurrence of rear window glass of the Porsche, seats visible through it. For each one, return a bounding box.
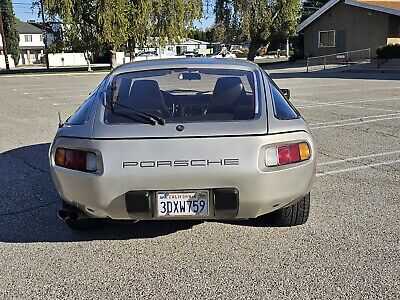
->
[104,69,258,124]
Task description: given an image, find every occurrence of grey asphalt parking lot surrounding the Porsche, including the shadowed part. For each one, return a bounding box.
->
[0,69,400,299]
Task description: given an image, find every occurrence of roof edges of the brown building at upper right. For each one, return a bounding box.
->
[296,0,400,32]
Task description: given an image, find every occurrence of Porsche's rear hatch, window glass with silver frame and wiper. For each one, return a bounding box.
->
[92,67,267,139]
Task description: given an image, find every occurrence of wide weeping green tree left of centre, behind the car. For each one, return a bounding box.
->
[43,0,202,67]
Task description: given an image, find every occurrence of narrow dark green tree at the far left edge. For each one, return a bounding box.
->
[0,0,20,65]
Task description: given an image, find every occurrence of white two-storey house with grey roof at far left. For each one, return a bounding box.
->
[0,22,44,67]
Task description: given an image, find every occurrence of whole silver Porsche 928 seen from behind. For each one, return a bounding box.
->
[49,58,316,229]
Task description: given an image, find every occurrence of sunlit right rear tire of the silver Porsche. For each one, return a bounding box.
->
[271,193,310,227]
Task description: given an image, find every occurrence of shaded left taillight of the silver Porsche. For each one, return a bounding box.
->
[54,148,96,172]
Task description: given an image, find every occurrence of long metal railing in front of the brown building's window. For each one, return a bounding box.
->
[307,48,371,72]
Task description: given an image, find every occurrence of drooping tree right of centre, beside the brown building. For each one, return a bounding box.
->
[215,0,301,61]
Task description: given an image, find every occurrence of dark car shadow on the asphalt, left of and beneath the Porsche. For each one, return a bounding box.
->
[0,144,201,243]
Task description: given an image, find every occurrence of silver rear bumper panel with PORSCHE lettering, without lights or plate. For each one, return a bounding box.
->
[50,131,316,220]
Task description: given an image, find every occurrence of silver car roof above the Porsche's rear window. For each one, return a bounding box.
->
[111,57,259,75]
